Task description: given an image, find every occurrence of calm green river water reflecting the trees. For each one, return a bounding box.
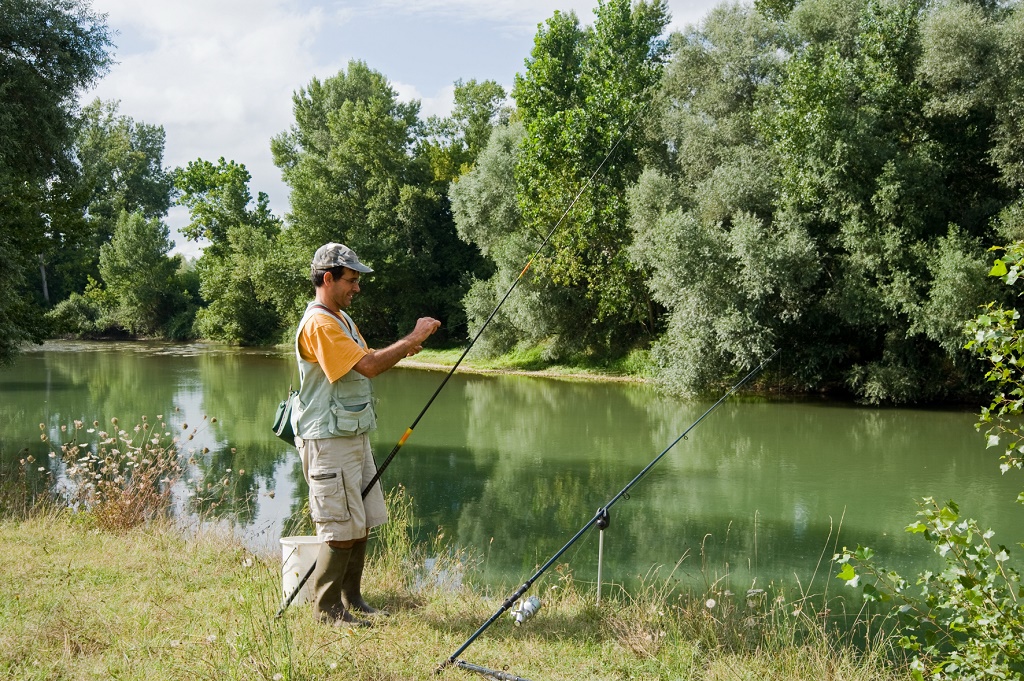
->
[0,343,1024,591]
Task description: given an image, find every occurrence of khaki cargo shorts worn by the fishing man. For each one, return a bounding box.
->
[296,434,387,542]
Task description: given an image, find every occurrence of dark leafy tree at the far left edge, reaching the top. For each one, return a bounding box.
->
[0,0,111,365]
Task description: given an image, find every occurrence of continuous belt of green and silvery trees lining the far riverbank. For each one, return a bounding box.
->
[6,0,1024,403]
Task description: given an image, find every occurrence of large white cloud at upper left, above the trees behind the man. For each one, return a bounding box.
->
[83,0,339,251]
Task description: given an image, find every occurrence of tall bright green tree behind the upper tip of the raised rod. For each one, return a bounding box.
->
[513,0,669,350]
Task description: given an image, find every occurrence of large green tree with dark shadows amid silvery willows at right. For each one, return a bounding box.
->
[763,1,1006,402]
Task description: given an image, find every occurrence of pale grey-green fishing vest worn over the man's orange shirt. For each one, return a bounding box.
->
[293,302,377,439]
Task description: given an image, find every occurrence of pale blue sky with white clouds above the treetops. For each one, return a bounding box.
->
[81,0,718,256]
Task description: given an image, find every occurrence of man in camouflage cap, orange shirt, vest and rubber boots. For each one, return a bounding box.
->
[294,243,440,627]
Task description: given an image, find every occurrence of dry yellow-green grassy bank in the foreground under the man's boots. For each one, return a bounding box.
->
[0,496,905,681]
